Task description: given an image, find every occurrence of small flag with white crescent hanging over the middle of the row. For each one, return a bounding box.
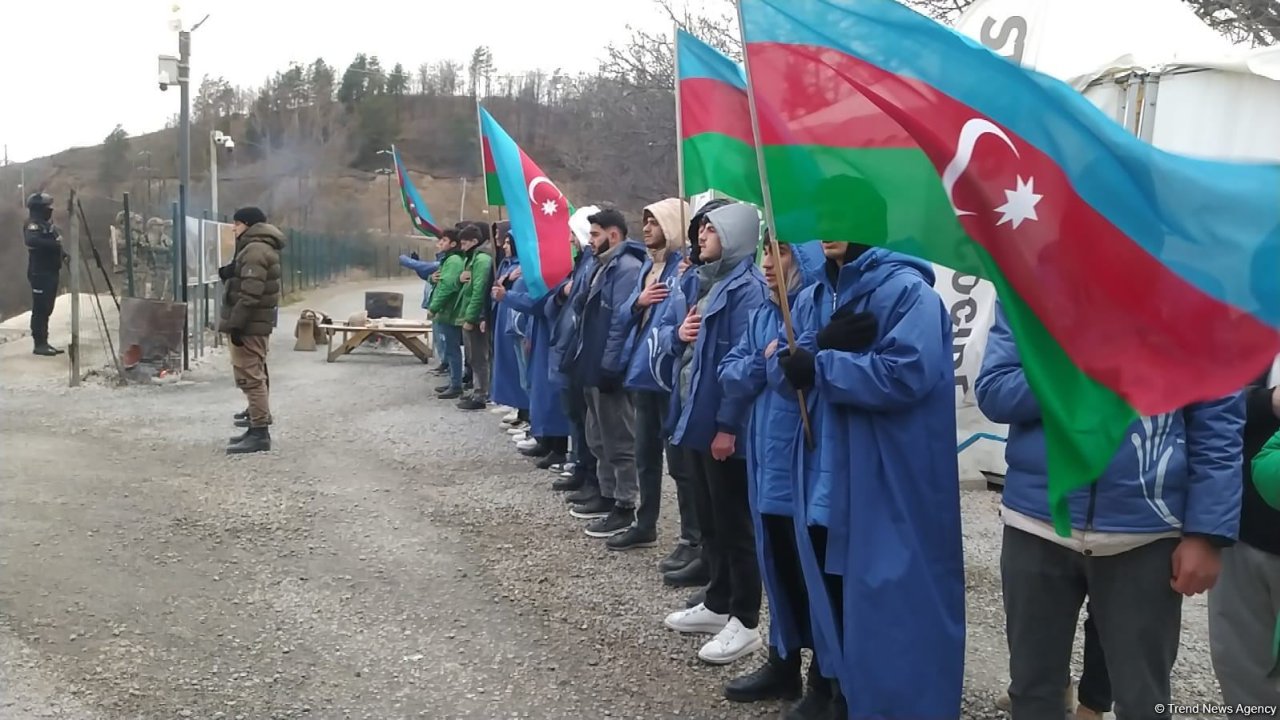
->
[480,108,575,297]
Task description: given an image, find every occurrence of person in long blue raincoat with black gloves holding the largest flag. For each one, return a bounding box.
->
[771,230,965,720]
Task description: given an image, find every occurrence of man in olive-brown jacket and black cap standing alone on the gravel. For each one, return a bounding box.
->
[218,208,284,455]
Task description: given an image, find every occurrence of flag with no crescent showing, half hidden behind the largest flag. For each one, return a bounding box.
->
[676,28,763,205]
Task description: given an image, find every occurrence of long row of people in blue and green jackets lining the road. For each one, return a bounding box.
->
[207,192,1280,720]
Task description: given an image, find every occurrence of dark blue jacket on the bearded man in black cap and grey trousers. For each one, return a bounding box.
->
[573,240,648,388]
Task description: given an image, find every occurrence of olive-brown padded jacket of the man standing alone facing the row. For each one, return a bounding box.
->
[218,223,284,336]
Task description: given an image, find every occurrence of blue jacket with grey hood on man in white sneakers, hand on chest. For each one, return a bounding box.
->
[658,204,769,459]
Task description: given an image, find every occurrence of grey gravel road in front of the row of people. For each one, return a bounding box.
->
[0,282,1217,720]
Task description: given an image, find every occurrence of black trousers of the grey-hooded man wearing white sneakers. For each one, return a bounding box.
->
[686,448,762,628]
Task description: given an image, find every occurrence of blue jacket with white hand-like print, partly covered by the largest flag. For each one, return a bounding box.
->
[974,301,1244,539]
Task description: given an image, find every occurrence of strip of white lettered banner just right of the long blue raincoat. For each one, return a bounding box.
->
[933,260,1009,480]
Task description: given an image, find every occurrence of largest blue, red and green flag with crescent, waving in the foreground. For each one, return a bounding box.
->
[740,0,1280,534]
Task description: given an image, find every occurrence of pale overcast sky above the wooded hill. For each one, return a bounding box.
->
[0,0,718,161]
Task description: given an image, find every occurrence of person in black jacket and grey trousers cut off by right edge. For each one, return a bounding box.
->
[1208,363,1280,719]
